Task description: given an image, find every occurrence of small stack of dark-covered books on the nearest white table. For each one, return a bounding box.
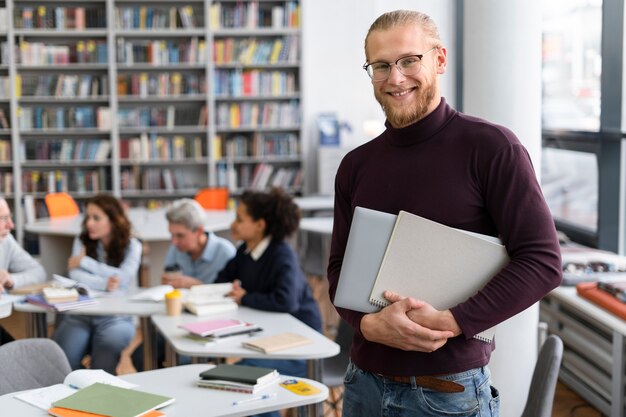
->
[198,364,280,394]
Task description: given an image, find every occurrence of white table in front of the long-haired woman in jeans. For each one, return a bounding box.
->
[13,288,165,369]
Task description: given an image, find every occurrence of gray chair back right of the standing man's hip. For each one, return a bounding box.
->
[522,335,563,417]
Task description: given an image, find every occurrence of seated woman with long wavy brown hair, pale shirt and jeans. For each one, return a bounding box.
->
[53,194,141,374]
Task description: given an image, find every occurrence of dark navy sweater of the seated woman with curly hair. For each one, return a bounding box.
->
[215,240,322,331]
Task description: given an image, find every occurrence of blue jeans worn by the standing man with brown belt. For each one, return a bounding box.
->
[343,362,500,417]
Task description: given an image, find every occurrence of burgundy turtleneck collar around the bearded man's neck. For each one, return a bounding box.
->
[383,97,457,146]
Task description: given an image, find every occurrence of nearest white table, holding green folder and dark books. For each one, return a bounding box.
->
[0,364,328,417]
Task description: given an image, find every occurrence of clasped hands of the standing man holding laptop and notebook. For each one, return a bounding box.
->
[361,297,454,352]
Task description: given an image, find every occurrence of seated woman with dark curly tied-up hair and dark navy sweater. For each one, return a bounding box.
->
[215,188,322,416]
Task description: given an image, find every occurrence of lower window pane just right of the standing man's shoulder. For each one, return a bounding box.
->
[541,148,598,233]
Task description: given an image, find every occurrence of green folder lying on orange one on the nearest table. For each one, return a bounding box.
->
[52,382,174,417]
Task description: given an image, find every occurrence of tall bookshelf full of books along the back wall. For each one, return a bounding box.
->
[0,0,303,239]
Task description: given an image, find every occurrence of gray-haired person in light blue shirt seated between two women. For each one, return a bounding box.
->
[161,198,235,288]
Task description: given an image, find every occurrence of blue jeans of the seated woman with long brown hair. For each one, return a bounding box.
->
[53,315,135,375]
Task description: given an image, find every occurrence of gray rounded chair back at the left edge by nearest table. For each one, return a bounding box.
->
[0,339,72,395]
